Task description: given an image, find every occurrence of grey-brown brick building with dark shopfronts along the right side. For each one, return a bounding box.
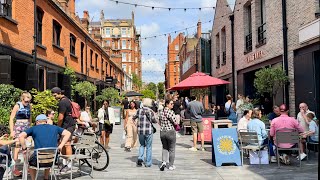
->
[212,0,319,115]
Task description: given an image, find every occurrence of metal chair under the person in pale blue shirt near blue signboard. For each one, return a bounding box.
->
[238,129,266,168]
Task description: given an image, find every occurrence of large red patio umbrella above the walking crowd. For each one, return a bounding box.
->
[169,72,230,90]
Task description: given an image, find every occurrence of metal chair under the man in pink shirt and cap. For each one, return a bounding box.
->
[276,128,301,168]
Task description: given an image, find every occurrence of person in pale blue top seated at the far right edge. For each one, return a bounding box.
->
[297,112,319,160]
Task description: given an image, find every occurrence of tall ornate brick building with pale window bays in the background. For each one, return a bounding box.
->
[89,11,142,90]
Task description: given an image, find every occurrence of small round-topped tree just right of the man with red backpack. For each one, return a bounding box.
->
[74,81,97,106]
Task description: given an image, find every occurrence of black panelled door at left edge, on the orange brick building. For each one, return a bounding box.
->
[0,55,11,84]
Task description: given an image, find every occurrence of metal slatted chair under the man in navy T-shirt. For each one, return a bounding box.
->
[29,147,57,179]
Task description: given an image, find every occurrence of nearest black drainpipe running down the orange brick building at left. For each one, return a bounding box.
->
[32,0,39,90]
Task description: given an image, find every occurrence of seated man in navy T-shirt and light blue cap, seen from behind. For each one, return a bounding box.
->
[19,114,71,180]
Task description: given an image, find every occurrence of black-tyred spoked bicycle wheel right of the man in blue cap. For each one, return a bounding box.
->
[84,141,109,171]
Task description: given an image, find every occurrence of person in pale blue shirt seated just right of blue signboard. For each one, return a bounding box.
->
[248,108,277,162]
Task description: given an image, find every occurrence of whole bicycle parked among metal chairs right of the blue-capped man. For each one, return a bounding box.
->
[73,126,109,171]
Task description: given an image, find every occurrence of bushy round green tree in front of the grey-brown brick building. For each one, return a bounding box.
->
[254,66,288,103]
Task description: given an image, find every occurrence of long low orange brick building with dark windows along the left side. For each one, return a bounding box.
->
[0,0,124,95]
